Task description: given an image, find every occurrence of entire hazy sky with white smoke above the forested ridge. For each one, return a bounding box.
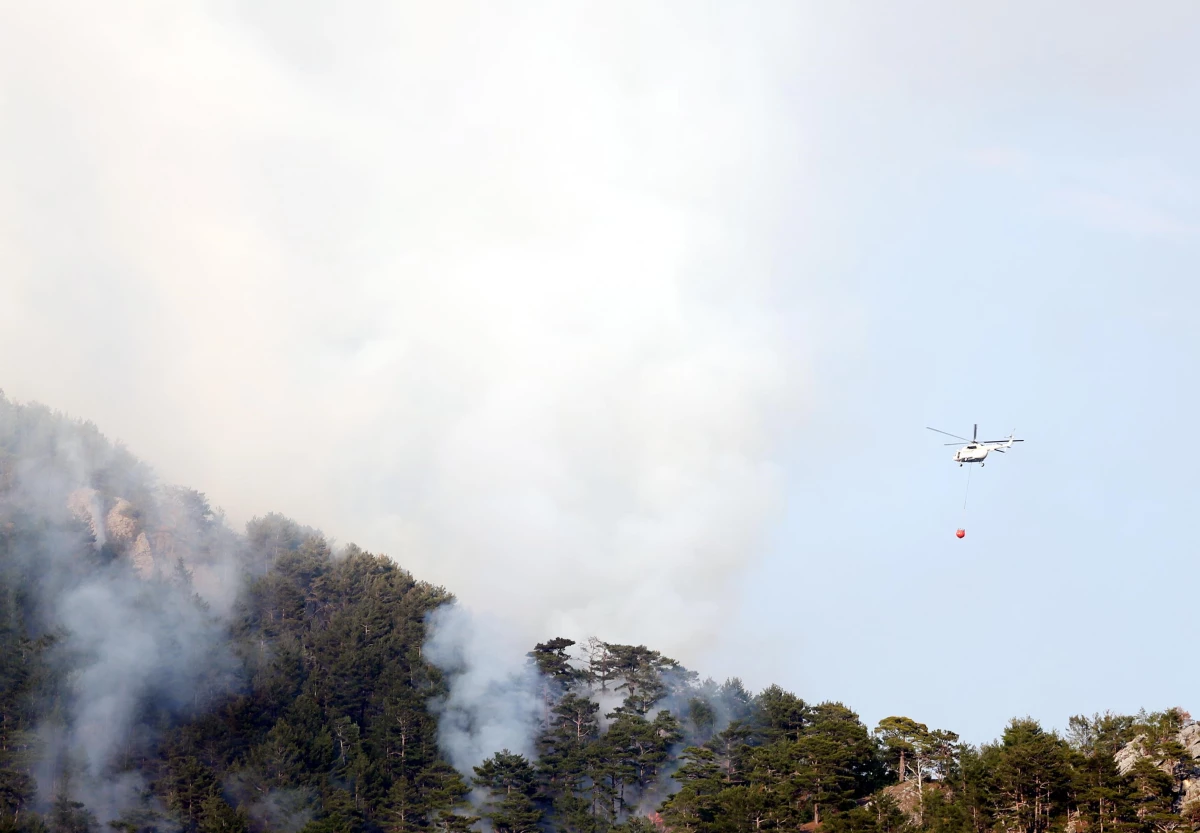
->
[0,0,1200,741]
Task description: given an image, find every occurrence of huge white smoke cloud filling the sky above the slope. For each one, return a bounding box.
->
[0,0,825,676]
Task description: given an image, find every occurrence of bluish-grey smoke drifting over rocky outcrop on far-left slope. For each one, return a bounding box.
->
[0,396,240,822]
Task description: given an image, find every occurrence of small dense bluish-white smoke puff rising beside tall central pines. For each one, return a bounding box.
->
[421,604,542,783]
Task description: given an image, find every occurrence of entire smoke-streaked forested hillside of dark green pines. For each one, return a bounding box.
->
[0,395,1200,833]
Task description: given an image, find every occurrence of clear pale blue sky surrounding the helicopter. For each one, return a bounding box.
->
[700,26,1200,742]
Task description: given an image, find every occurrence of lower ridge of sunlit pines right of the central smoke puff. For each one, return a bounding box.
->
[475,640,1200,833]
